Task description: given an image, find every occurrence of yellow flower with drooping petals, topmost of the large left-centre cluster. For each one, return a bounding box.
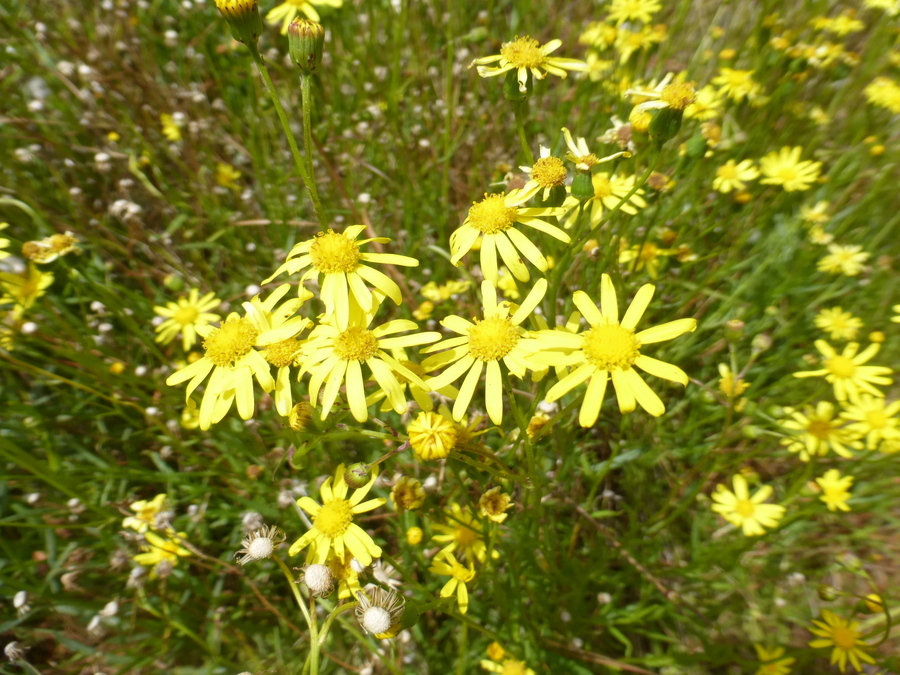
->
[263,225,419,330]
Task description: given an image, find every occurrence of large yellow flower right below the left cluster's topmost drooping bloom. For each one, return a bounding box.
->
[301,296,441,422]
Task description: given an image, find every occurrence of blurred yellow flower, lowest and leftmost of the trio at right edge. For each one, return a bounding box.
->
[780,401,862,462]
